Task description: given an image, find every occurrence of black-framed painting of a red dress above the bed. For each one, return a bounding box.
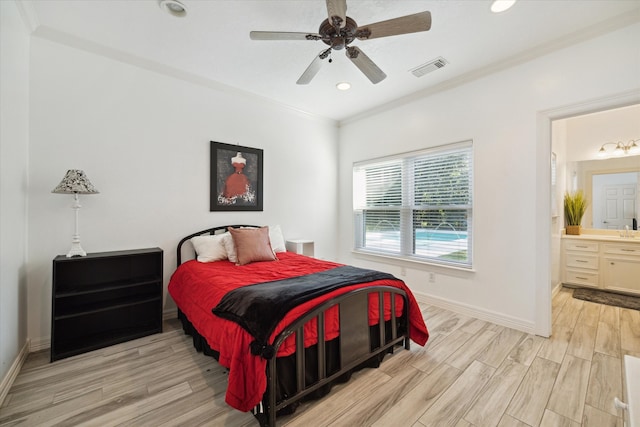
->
[209,141,263,211]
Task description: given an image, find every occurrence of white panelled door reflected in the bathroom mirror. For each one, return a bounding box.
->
[602,184,636,230]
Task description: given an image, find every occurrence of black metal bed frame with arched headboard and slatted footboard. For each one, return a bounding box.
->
[177,225,410,427]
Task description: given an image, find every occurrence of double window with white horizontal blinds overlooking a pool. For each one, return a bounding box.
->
[353,141,473,268]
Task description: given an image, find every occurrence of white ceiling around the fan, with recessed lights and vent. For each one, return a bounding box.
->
[21,0,640,120]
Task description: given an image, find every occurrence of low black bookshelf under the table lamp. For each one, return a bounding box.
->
[51,248,163,362]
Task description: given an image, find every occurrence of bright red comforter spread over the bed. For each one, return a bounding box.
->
[169,252,429,411]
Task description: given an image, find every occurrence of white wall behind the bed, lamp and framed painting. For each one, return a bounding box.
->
[28,37,337,347]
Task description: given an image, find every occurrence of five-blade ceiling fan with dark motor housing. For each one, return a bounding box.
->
[249,0,431,85]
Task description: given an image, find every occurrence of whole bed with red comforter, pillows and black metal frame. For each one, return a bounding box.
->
[168,225,429,426]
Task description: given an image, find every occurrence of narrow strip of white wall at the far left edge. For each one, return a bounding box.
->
[0,1,29,394]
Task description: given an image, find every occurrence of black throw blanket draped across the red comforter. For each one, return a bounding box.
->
[212,266,397,359]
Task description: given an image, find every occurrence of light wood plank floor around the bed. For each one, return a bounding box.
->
[0,289,640,427]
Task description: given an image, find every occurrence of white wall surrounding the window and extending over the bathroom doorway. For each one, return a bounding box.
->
[339,24,640,331]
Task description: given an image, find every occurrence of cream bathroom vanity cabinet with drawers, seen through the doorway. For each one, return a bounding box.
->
[562,236,640,294]
